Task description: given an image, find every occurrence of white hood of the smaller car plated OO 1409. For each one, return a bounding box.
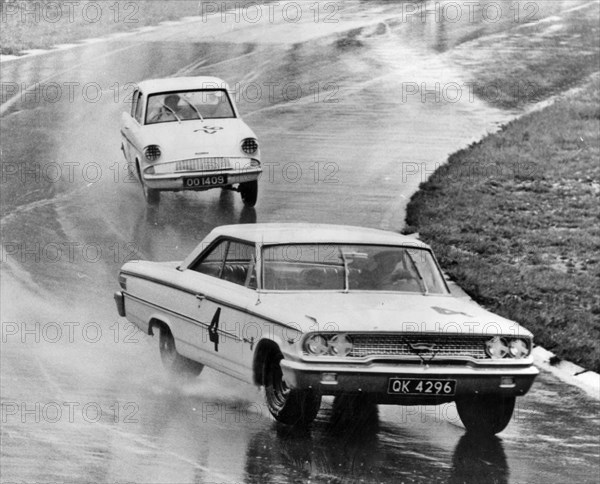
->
[144,118,256,161]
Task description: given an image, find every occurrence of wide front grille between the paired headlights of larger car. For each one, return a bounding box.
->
[348,334,490,360]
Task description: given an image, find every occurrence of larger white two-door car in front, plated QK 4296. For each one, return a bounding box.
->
[115,224,538,434]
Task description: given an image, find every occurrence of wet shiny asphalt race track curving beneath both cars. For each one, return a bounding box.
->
[0,1,600,483]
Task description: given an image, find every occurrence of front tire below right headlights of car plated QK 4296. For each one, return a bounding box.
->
[456,395,516,435]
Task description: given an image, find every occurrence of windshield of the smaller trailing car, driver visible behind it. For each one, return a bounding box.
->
[146,89,235,124]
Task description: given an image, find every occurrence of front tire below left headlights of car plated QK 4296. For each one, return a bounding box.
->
[263,353,321,427]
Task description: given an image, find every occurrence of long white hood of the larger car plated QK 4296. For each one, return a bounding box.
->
[254,292,531,336]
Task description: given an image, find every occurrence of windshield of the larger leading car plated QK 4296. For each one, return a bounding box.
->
[262,244,448,294]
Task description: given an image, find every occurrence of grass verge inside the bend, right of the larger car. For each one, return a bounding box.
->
[406,76,600,371]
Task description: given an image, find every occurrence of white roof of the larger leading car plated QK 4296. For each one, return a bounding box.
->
[210,223,429,248]
